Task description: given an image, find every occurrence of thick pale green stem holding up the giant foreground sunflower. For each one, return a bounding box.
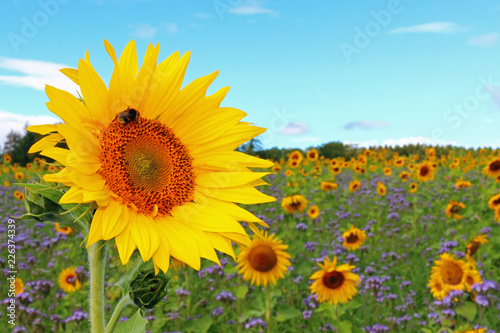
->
[87,241,107,333]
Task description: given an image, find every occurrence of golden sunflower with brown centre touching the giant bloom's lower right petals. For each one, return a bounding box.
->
[236,232,292,287]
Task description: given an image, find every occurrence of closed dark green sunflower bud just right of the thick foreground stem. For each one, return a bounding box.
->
[130,270,168,309]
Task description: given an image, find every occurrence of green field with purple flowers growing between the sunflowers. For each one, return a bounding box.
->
[0,152,500,333]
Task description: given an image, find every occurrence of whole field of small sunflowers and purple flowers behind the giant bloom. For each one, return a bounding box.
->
[0,147,500,333]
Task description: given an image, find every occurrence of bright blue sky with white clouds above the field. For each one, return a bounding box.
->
[0,0,500,148]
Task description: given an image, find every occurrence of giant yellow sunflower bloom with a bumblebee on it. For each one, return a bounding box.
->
[29,41,275,272]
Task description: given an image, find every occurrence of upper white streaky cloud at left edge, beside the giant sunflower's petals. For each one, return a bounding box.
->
[0,57,80,93]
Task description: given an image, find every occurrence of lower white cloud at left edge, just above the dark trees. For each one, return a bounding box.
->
[0,110,62,147]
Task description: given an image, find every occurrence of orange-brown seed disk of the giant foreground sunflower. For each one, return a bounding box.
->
[98,116,195,216]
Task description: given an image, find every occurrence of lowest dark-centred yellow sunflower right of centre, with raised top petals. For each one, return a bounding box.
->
[309,257,359,305]
